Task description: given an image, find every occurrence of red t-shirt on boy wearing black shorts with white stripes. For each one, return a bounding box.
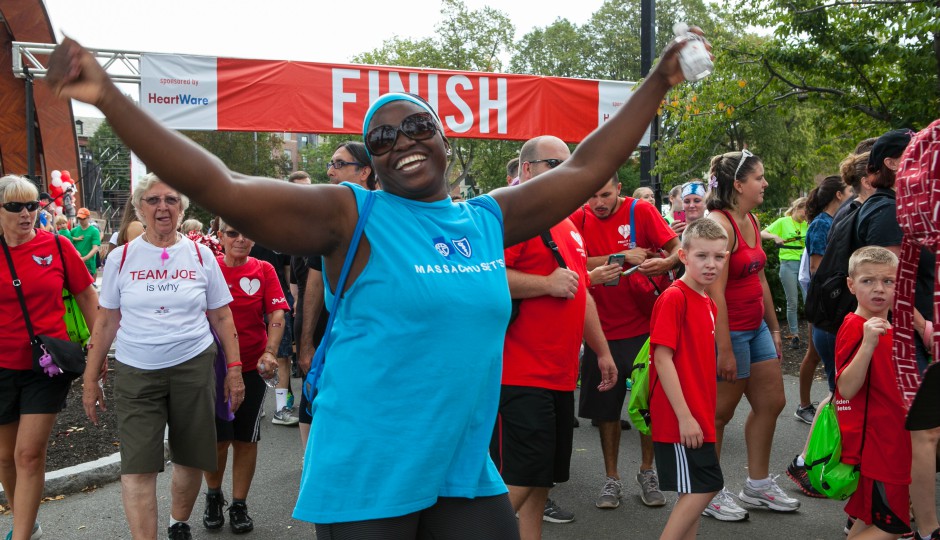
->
[649,280,718,443]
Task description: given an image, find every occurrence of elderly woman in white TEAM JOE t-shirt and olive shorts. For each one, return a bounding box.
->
[83,174,244,539]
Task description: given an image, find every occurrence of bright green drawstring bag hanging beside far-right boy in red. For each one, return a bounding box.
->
[805,402,864,501]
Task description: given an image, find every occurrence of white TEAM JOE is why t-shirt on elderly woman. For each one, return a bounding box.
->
[99,236,232,369]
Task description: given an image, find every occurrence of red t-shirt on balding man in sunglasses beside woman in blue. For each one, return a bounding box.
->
[503,219,588,392]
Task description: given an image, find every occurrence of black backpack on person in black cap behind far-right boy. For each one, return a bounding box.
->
[804,193,894,334]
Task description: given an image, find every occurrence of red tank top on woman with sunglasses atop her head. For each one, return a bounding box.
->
[716,210,767,332]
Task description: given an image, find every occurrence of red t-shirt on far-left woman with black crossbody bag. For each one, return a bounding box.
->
[0,230,93,369]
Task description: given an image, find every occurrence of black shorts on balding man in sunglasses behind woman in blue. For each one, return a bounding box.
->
[490,385,574,488]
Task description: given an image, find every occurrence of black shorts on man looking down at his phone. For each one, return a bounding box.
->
[578,334,649,422]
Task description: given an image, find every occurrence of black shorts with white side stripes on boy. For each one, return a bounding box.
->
[653,442,725,493]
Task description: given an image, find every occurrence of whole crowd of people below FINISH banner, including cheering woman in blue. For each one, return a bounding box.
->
[0,26,940,540]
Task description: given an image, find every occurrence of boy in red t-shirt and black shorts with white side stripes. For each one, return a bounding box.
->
[649,219,728,540]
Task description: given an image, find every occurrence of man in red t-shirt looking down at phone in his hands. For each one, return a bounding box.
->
[571,175,679,508]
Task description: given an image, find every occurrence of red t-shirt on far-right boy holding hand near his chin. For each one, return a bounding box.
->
[835,313,911,484]
